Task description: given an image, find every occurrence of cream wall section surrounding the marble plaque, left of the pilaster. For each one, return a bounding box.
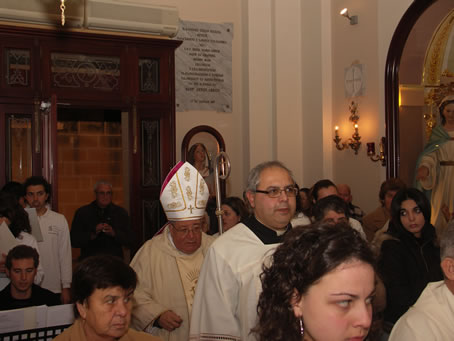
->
[134,0,249,196]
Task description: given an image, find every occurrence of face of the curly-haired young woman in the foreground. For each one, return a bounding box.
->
[293,260,375,341]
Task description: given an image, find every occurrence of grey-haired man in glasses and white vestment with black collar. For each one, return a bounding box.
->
[190,161,299,341]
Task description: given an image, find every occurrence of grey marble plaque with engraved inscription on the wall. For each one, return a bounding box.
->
[175,21,233,112]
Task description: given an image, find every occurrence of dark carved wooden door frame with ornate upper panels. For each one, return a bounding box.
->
[0,24,181,247]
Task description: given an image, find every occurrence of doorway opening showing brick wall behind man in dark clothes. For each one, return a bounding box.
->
[57,106,129,236]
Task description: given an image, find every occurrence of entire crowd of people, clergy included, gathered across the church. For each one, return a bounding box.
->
[0,146,454,341]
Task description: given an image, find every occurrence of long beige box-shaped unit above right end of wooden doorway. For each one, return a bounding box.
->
[85,0,179,37]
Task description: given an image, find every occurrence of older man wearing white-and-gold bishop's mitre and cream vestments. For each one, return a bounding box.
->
[131,162,213,341]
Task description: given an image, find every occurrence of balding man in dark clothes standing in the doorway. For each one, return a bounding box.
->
[71,181,134,259]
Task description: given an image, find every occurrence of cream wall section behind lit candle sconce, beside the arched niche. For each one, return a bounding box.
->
[331,0,412,212]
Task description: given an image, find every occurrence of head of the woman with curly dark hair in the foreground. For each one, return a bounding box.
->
[252,224,375,341]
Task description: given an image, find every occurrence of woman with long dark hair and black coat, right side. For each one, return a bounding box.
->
[378,188,443,331]
